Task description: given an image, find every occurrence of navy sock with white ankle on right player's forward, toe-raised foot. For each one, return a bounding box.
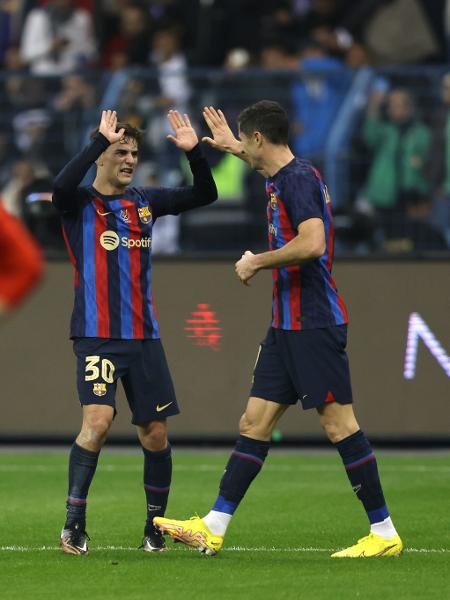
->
[203,435,270,536]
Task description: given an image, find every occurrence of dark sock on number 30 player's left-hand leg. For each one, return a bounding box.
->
[64,442,100,530]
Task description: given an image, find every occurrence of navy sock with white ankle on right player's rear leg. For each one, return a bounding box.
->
[335,431,396,537]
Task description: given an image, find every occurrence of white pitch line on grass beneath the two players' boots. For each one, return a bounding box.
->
[0,546,450,554]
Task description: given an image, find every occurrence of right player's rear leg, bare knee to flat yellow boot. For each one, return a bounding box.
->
[318,402,403,557]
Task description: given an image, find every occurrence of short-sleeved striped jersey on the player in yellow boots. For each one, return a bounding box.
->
[266,158,348,331]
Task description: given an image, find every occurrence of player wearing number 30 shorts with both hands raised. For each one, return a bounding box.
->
[53,110,217,554]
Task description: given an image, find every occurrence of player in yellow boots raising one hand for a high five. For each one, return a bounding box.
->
[155,100,403,557]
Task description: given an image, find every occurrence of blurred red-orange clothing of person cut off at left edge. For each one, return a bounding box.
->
[0,202,43,317]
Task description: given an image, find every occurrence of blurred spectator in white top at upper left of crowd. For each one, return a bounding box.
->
[21,0,96,75]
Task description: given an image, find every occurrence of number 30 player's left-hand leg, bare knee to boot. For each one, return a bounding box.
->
[61,404,114,554]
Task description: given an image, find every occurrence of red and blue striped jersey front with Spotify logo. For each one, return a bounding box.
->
[62,186,161,339]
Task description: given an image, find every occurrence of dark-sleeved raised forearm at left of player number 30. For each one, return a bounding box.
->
[53,133,109,208]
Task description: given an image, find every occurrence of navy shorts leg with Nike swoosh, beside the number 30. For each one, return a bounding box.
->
[122,340,180,425]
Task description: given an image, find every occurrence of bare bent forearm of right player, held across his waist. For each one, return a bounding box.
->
[254,236,325,270]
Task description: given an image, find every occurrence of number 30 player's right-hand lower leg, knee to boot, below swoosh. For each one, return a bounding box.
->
[137,419,172,552]
